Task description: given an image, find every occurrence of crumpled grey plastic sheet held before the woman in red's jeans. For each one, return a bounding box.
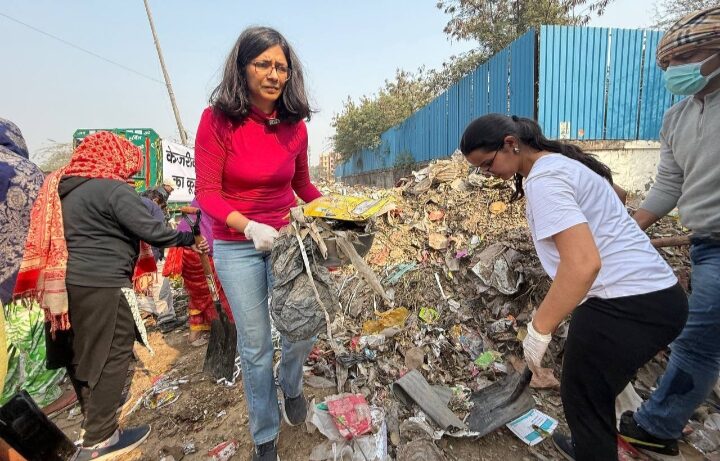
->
[270,234,339,342]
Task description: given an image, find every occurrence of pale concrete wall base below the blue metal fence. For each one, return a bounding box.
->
[340,141,660,195]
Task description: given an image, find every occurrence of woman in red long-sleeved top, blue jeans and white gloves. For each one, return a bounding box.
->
[195,27,321,461]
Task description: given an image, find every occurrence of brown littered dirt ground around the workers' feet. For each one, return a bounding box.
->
[46,329,559,461]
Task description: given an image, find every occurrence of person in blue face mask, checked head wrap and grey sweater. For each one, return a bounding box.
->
[620,7,720,459]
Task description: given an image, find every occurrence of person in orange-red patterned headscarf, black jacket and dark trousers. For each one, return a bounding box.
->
[15,132,207,461]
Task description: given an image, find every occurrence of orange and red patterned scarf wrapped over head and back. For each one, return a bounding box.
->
[14,131,156,332]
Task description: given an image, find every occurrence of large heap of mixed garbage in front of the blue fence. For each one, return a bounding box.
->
[307,156,689,460]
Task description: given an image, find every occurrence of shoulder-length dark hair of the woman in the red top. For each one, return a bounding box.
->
[210,27,312,123]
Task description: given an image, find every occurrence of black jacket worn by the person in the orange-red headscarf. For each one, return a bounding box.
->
[58,176,194,288]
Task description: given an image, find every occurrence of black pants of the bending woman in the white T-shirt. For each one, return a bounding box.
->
[561,285,688,461]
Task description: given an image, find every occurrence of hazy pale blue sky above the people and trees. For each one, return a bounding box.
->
[0,0,653,163]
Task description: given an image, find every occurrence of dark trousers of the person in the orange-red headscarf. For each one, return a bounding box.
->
[56,285,135,446]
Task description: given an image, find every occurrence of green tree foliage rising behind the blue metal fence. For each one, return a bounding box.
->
[332,0,612,162]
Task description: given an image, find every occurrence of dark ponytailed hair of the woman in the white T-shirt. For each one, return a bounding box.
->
[460,114,612,202]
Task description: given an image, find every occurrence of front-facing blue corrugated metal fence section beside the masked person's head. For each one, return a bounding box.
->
[537,26,672,140]
